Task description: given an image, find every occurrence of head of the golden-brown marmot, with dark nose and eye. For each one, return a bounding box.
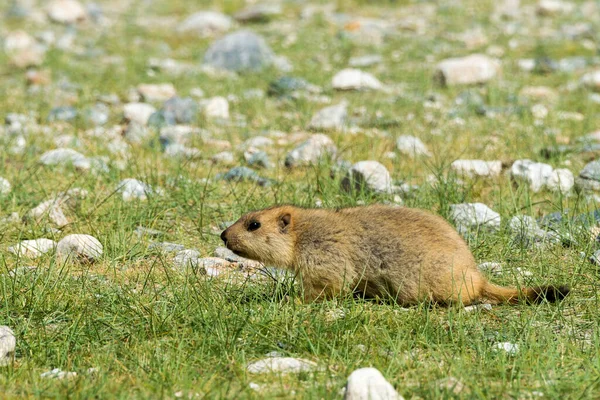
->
[221,206,295,268]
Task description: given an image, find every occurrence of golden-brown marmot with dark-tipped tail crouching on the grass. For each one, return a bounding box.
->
[221,205,569,305]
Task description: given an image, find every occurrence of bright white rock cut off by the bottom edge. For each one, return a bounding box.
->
[344,368,403,400]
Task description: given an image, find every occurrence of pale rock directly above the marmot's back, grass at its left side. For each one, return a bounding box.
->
[342,161,392,193]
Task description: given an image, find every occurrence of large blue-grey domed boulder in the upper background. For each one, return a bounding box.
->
[204,30,274,72]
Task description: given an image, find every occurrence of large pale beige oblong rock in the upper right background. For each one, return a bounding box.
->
[435,54,500,86]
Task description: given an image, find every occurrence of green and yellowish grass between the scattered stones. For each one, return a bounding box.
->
[0,0,600,399]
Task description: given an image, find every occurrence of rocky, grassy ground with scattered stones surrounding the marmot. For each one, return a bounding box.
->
[0,0,600,399]
